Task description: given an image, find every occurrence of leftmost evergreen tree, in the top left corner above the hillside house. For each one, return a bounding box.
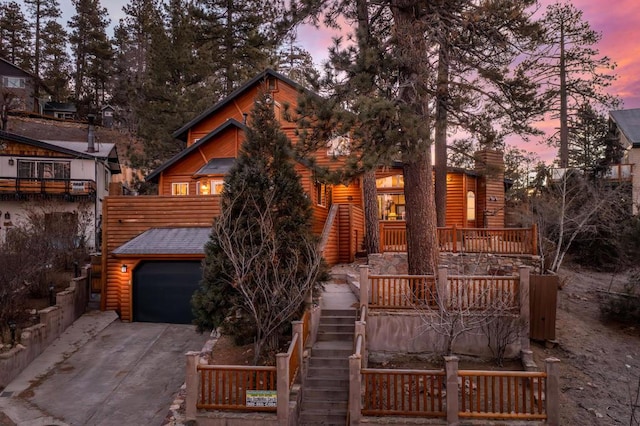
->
[0,1,31,70]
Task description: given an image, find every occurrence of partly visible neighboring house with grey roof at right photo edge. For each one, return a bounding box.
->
[609,108,640,214]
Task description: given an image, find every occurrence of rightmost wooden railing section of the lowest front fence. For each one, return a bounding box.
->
[458,370,547,420]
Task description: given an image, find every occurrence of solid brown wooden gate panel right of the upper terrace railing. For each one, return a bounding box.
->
[529,275,559,340]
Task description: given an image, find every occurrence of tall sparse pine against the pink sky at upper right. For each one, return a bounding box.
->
[521,3,619,168]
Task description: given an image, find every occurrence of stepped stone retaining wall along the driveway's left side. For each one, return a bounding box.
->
[0,266,91,388]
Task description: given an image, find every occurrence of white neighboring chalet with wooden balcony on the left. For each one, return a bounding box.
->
[0,125,120,249]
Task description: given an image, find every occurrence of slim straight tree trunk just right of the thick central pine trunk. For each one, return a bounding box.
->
[434,41,449,227]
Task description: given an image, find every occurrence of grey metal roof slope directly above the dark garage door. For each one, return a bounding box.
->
[113,227,211,255]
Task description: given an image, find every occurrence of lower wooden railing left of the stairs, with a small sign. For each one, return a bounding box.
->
[196,365,277,411]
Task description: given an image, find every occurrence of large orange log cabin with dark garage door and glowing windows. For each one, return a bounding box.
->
[101,70,505,323]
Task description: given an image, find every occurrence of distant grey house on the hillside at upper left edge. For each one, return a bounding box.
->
[0,58,39,112]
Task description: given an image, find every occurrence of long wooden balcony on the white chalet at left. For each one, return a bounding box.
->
[0,176,96,201]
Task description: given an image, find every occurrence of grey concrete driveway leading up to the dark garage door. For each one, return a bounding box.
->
[0,312,207,426]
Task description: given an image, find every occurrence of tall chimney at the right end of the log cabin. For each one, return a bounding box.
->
[474,149,505,228]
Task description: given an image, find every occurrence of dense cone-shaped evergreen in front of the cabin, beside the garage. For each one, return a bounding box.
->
[193,93,323,361]
